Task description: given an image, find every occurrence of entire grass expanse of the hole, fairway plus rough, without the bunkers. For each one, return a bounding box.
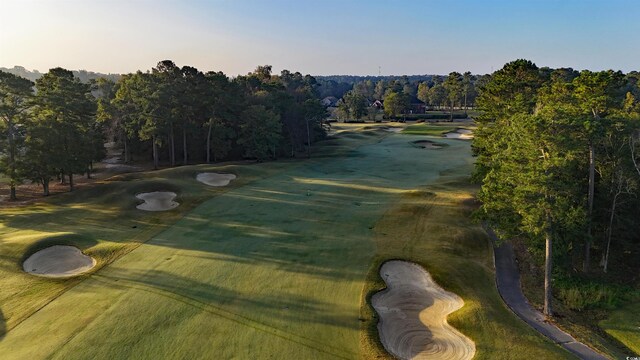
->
[0,126,570,359]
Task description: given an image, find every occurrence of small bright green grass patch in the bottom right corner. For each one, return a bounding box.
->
[599,302,640,356]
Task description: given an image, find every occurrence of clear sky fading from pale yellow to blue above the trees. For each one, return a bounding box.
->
[0,0,640,75]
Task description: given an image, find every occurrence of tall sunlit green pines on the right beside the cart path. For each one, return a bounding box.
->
[473,60,640,315]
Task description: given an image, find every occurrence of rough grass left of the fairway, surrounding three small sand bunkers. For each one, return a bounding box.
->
[0,160,296,336]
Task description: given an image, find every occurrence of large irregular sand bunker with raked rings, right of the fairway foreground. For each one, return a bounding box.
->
[371,260,476,360]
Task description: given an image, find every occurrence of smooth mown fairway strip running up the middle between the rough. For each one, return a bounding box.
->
[0,130,568,359]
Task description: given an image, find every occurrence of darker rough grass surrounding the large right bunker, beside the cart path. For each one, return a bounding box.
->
[360,180,573,359]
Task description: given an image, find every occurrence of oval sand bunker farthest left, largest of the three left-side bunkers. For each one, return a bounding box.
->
[22,245,96,277]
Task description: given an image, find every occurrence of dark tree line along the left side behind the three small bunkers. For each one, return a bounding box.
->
[0,60,326,199]
